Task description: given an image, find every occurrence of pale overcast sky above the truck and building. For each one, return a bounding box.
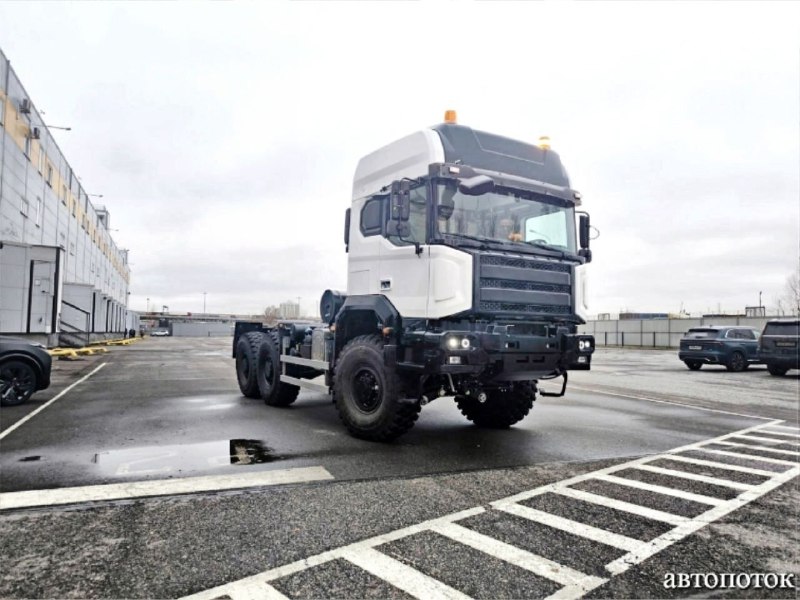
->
[0,2,800,313]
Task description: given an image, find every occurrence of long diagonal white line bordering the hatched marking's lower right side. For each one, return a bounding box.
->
[606,468,800,575]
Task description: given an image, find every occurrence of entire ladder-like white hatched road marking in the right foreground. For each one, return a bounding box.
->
[181,421,800,600]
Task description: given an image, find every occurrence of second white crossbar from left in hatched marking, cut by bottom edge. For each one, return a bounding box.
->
[342,548,469,600]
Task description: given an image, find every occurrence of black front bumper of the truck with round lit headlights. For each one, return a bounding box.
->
[396,326,594,381]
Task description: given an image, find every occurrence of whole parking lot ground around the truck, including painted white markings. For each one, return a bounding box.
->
[0,338,800,598]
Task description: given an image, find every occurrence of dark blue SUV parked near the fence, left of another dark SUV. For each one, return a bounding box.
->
[678,325,761,371]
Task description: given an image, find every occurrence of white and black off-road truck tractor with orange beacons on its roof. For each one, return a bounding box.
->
[233,111,594,441]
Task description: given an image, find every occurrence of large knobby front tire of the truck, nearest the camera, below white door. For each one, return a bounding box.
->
[334,335,420,442]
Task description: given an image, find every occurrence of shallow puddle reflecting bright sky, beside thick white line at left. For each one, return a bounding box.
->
[93,440,285,475]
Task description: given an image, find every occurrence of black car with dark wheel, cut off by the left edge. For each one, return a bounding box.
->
[0,336,53,406]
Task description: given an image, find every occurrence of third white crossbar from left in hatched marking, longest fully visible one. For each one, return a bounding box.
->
[431,523,605,591]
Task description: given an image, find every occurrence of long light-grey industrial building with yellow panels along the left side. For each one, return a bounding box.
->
[0,51,139,346]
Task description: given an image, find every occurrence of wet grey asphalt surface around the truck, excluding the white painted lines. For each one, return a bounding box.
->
[0,338,800,598]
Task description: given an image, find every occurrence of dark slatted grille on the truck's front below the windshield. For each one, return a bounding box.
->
[475,254,572,316]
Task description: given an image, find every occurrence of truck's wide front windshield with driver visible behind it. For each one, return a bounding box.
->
[436,181,576,253]
